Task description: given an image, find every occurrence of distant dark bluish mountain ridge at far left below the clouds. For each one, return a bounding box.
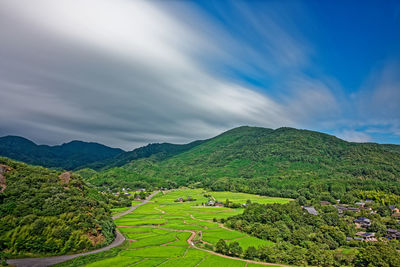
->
[0,136,124,170]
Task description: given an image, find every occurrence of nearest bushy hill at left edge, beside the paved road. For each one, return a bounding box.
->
[0,157,115,255]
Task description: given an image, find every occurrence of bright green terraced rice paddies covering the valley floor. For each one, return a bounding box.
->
[62,189,290,267]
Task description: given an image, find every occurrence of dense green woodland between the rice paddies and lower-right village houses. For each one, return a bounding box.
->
[223,202,400,266]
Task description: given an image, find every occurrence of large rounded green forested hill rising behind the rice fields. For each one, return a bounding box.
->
[92,127,400,198]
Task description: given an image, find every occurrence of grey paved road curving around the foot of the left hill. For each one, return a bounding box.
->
[7,191,158,267]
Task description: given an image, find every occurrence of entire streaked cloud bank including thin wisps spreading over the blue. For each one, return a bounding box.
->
[0,0,400,149]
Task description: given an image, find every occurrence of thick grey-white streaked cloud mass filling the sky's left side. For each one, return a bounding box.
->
[0,0,304,149]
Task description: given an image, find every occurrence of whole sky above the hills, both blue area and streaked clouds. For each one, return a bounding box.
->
[0,0,400,150]
